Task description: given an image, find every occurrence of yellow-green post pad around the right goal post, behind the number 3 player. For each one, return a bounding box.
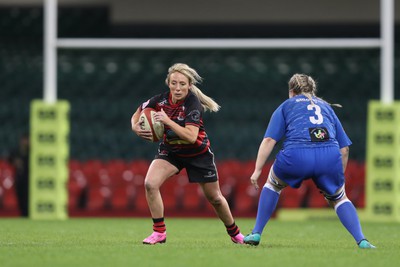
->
[366,101,400,222]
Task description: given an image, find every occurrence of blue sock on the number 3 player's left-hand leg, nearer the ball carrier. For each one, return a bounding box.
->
[252,187,279,234]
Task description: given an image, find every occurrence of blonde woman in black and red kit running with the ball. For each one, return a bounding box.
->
[131,63,243,244]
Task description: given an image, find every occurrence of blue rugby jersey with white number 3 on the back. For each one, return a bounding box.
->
[264,95,351,149]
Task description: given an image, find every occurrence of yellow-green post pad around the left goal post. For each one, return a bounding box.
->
[29,100,70,219]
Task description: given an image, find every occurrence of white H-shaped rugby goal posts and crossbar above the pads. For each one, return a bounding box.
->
[44,0,394,103]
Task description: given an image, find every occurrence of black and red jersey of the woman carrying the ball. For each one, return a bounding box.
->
[141,91,210,157]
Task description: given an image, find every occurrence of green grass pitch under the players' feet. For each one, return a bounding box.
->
[0,218,400,267]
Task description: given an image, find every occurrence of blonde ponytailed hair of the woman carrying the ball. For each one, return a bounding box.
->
[165,63,221,112]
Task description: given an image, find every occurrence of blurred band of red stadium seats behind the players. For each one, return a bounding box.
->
[0,160,365,216]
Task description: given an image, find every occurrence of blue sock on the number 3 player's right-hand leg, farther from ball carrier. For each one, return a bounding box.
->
[336,201,365,244]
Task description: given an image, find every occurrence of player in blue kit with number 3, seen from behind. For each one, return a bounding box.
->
[244,74,375,248]
